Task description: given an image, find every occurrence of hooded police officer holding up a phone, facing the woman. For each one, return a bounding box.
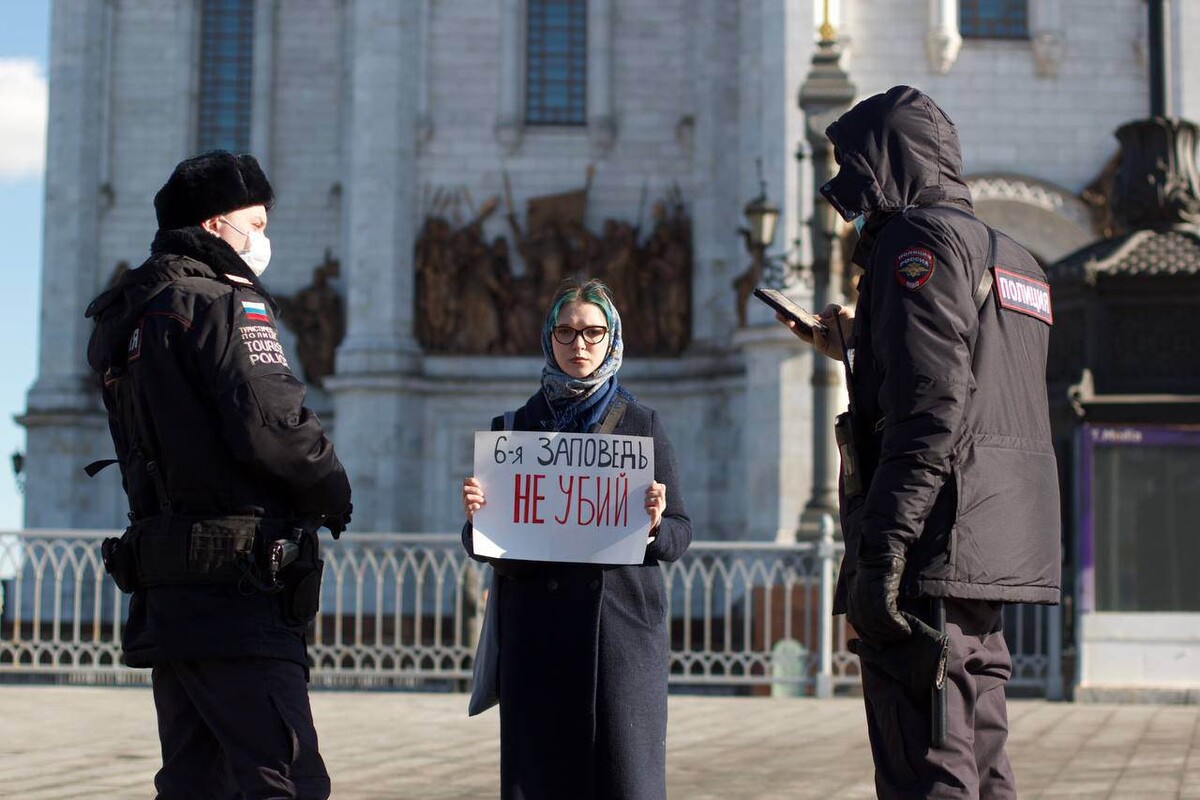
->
[797,86,1060,800]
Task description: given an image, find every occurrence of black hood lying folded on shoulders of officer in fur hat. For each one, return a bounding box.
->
[84,227,278,374]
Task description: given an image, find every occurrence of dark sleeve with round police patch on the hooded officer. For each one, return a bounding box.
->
[860,221,979,554]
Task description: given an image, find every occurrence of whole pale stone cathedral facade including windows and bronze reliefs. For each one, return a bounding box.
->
[22,0,1200,540]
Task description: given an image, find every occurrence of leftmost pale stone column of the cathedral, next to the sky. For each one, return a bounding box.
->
[19,2,112,528]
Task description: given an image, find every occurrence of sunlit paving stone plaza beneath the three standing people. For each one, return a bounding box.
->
[0,685,1200,800]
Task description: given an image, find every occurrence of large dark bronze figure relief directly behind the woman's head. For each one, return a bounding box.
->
[413,188,692,356]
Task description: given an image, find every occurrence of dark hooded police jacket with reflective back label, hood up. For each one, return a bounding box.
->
[822,86,1061,612]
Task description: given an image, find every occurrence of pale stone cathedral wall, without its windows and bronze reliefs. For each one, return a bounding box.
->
[26,0,1171,539]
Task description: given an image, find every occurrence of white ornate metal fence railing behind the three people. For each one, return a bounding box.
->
[0,525,1061,697]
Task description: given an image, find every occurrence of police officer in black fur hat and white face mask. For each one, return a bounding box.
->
[88,151,350,800]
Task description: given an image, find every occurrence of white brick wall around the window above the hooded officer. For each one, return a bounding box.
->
[847,0,1148,192]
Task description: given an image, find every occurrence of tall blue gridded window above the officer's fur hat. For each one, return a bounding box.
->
[196,0,254,152]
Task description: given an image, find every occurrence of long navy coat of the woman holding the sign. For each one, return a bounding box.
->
[463,392,691,800]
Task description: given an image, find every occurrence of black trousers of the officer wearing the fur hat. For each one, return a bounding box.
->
[152,658,330,800]
